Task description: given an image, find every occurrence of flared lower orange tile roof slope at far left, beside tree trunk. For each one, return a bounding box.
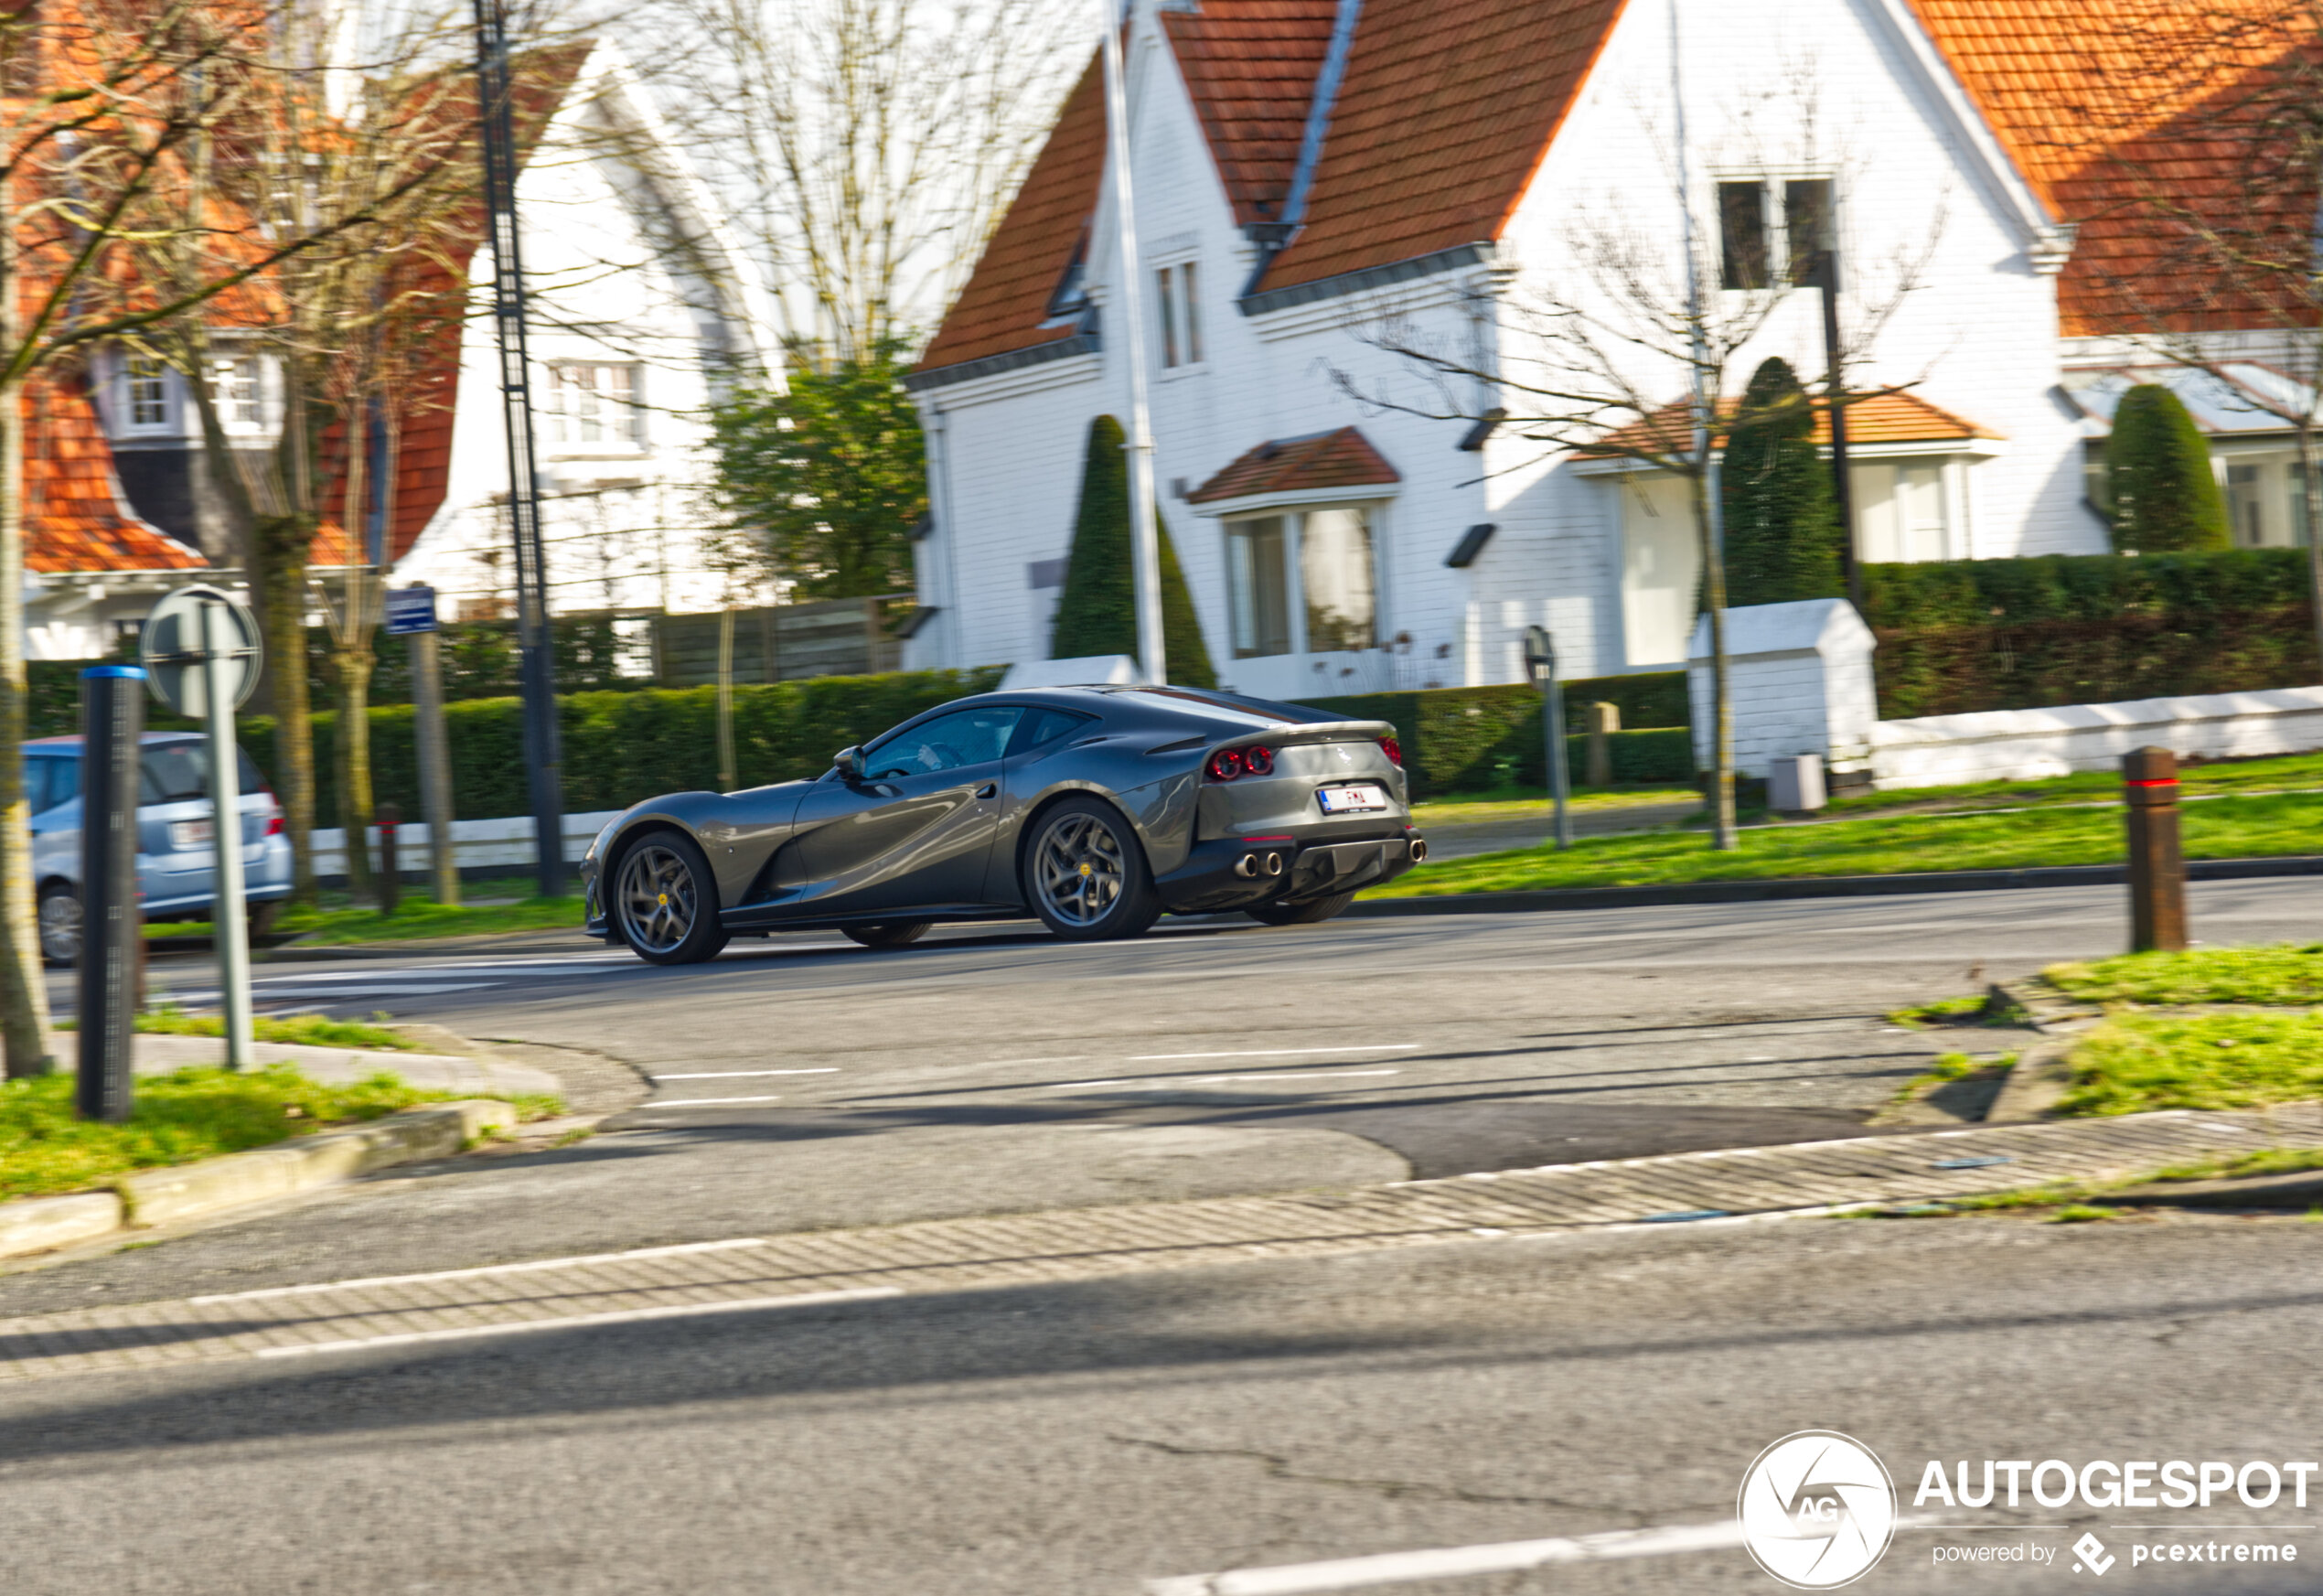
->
[21,371,209,572]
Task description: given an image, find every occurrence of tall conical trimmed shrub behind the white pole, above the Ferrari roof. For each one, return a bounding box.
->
[1048,416,1217,688]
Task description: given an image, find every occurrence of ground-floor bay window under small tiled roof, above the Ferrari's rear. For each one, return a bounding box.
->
[1226,504,1380,659]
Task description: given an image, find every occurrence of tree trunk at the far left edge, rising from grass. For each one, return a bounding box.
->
[0,379,56,1080]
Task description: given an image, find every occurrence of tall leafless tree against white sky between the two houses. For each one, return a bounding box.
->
[646,0,1089,360]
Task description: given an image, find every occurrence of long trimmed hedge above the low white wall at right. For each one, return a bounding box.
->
[1863,548,2323,720]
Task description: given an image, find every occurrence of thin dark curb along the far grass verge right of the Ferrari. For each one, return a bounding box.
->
[1343,852,2323,917]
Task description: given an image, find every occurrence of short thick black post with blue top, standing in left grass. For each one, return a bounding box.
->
[74,664,144,1124]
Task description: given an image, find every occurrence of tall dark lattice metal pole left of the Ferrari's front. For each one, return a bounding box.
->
[476,0,564,896]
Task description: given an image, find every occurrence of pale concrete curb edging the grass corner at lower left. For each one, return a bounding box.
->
[0,1097,516,1257]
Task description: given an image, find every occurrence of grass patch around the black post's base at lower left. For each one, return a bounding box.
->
[0,1064,453,1196]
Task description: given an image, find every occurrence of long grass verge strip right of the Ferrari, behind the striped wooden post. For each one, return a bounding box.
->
[1376,795,2323,896]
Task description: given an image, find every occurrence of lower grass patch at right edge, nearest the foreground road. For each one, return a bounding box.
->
[2056,1012,2323,1115]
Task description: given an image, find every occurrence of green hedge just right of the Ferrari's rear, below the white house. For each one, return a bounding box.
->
[1303,671,1694,799]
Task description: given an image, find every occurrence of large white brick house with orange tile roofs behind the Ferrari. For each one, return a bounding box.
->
[911,0,2174,694]
